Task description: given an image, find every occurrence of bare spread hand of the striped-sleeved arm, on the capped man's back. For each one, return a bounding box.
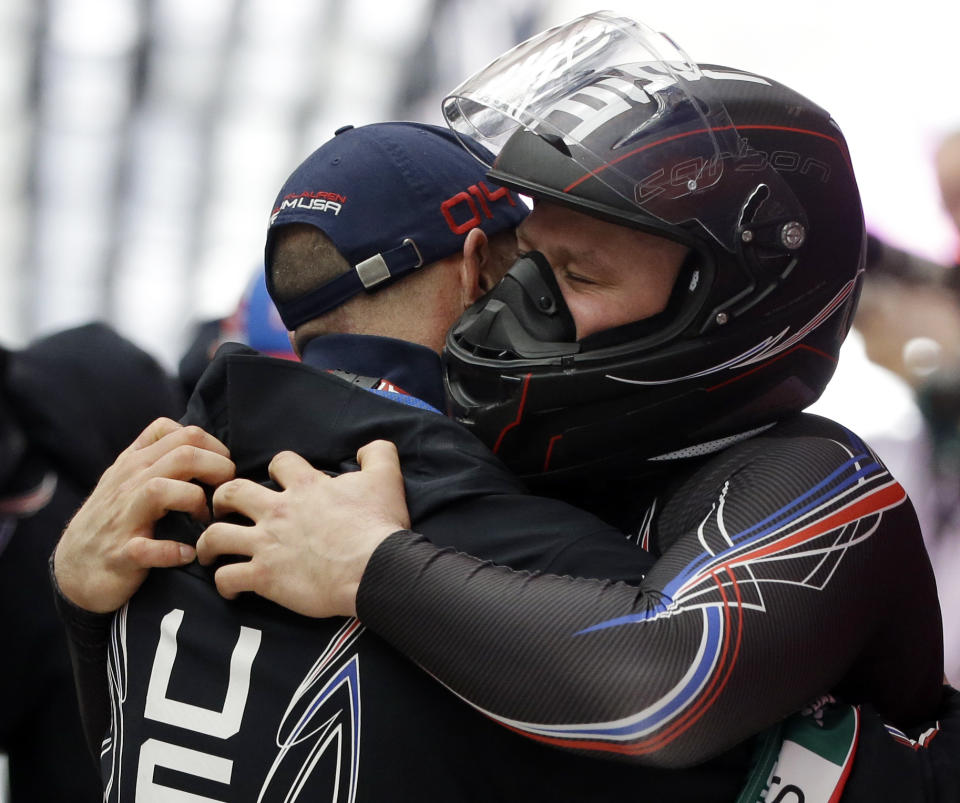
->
[197,441,410,617]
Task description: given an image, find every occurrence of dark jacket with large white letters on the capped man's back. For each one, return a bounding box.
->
[56,340,750,801]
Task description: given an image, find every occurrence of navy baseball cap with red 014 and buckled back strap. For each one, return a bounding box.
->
[265,122,528,330]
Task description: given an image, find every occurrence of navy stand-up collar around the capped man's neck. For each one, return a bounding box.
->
[303,334,446,411]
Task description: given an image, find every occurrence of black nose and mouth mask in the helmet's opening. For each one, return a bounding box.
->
[450,251,580,359]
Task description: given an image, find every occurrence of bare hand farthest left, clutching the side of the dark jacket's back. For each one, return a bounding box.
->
[54,418,235,613]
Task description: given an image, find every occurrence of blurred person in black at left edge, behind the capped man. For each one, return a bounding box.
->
[0,324,181,803]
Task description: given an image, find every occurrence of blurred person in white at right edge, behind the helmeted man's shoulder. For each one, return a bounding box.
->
[808,235,960,682]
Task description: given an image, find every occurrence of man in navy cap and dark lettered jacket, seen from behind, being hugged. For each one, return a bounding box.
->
[53,124,750,801]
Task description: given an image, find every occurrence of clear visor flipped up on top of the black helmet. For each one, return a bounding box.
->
[443,12,795,250]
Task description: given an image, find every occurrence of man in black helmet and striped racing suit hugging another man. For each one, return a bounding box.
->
[198,14,955,800]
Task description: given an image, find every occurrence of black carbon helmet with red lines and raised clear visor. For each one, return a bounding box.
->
[444,13,865,484]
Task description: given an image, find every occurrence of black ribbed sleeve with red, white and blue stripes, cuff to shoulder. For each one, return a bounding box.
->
[357,438,942,767]
